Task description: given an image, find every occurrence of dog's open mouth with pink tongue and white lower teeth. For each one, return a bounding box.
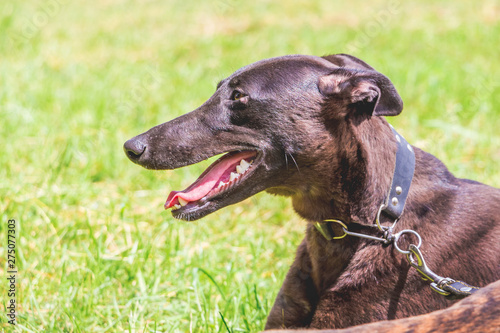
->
[165,150,257,217]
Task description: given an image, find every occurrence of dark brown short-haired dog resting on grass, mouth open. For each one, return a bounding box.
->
[124,55,500,329]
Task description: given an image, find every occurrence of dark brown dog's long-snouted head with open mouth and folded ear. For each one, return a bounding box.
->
[124,55,403,220]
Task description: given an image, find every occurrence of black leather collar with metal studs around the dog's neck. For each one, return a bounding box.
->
[314,125,415,240]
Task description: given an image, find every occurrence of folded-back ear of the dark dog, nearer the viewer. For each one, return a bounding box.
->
[318,68,403,116]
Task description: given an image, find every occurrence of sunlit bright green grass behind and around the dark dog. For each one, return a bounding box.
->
[0,0,500,332]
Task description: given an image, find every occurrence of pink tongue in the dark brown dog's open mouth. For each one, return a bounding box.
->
[165,151,255,209]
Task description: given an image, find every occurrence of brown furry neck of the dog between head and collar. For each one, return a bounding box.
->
[292,117,397,225]
